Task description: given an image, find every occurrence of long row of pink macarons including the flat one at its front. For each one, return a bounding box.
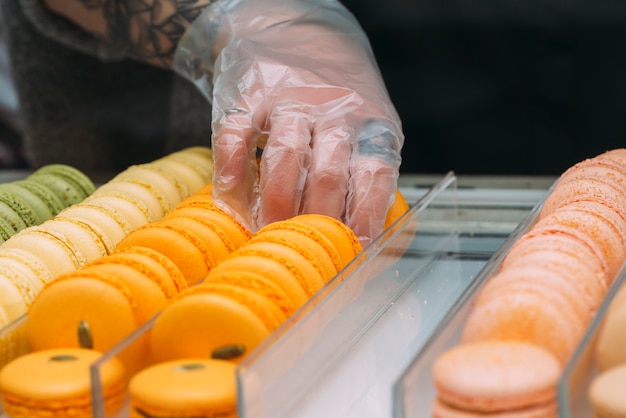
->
[433,149,626,416]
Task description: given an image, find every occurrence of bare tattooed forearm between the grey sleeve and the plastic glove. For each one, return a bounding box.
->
[44,0,211,68]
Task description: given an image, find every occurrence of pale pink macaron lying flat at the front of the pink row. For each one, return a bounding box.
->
[432,341,561,416]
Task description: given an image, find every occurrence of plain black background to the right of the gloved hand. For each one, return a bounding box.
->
[343,0,626,175]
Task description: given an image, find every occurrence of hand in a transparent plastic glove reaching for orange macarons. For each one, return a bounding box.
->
[174,0,404,244]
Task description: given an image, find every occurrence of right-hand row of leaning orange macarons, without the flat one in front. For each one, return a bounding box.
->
[144,214,361,362]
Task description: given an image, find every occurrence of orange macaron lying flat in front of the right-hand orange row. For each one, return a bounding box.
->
[129,357,237,418]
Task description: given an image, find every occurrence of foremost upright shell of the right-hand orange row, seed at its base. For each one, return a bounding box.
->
[150,293,270,362]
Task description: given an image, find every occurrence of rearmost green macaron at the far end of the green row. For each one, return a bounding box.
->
[27,164,96,207]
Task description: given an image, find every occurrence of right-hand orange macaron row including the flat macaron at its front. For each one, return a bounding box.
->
[124,212,361,417]
